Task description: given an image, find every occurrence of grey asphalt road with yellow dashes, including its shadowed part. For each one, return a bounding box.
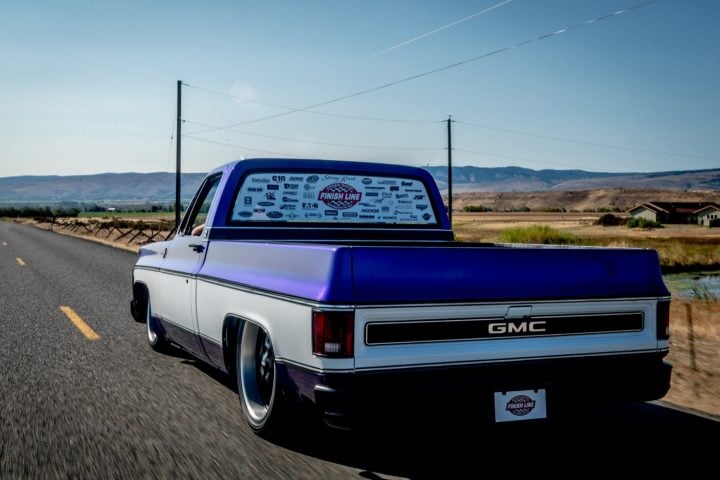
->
[0,222,720,479]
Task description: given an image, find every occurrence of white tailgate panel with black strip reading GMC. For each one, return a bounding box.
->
[355,299,658,371]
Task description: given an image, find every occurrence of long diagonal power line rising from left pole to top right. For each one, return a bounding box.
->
[190,0,660,134]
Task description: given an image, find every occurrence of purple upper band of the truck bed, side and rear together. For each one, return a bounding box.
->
[199,241,669,305]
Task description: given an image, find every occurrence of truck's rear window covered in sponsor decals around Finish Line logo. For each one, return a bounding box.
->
[230,172,438,225]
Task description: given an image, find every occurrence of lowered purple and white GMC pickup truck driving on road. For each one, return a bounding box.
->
[131,159,671,433]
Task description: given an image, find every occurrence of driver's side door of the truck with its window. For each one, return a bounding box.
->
[158,173,222,355]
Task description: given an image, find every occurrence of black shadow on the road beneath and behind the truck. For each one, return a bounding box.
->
[272,403,720,479]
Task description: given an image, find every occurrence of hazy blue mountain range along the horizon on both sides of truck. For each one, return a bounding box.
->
[0,166,720,203]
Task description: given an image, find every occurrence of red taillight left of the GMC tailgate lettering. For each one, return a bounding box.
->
[312,310,355,358]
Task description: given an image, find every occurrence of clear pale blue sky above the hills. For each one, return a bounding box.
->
[0,0,720,177]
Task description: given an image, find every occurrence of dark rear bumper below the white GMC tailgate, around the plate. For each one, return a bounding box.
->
[278,351,672,428]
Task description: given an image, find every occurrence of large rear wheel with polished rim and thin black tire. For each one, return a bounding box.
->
[235,322,284,435]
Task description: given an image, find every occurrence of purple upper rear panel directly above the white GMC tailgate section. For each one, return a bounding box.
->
[352,244,669,304]
